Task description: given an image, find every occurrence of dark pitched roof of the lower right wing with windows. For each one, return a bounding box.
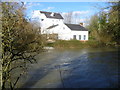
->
[65,24,88,31]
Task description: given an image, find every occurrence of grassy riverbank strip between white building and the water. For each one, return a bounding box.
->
[46,40,118,49]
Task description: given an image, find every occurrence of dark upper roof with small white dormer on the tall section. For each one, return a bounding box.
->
[40,11,63,19]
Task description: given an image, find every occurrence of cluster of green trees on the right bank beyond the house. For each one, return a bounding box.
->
[87,2,120,44]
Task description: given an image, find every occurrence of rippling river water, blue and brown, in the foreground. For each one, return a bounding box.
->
[22,48,120,88]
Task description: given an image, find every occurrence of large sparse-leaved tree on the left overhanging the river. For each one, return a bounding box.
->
[0,2,43,90]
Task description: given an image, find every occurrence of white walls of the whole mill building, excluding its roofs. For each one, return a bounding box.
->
[34,11,88,40]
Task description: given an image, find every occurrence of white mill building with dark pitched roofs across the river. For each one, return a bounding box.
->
[33,11,88,40]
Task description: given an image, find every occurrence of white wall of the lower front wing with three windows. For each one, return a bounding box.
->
[44,24,88,40]
